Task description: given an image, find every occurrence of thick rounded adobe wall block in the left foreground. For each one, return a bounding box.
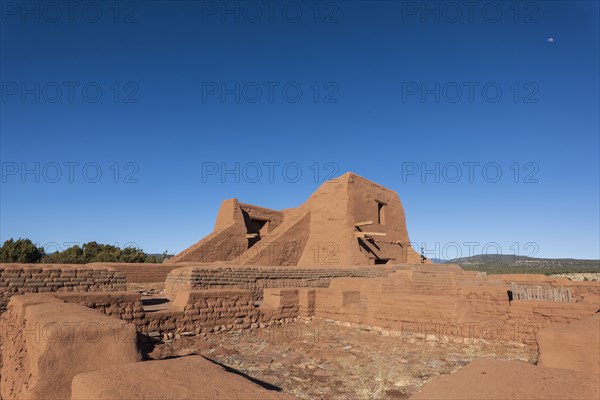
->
[0,294,141,400]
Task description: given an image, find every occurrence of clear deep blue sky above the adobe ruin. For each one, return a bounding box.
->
[0,0,600,259]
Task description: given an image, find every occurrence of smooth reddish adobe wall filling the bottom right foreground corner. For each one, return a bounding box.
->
[411,316,600,400]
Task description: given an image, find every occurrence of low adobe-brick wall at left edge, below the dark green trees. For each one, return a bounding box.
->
[0,264,126,313]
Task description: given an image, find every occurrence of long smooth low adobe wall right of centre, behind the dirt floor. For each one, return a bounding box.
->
[315,266,600,344]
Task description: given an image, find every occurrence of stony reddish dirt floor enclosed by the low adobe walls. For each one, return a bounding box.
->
[146,319,537,399]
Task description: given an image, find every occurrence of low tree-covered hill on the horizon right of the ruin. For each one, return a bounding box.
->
[447,254,600,274]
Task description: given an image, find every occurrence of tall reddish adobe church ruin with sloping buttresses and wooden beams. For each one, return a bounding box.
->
[169,172,421,268]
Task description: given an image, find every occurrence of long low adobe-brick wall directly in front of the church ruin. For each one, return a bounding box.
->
[165,265,400,300]
